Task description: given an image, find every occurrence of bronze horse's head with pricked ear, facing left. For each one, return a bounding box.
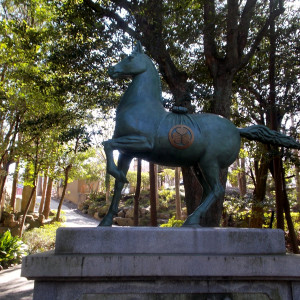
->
[108,41,147,79]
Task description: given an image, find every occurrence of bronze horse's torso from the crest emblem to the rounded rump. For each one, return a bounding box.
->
[150,113,240,168]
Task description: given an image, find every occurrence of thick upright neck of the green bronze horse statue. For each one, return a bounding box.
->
[118,65,164,110]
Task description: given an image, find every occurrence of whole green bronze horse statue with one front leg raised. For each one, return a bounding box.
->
[99,42,300,226]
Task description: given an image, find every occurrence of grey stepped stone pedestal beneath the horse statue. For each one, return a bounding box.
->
[22,227,300,300]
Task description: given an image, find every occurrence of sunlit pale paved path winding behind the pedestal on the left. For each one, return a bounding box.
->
[0,200,99,300]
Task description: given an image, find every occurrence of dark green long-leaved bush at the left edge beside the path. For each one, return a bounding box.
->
[0,230,27,268]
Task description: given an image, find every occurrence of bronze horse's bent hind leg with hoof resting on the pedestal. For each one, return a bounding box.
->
[183,165,225,226]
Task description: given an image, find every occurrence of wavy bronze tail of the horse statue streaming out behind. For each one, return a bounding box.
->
[238,125,300,149]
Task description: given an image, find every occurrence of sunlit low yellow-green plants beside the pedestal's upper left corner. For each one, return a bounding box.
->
[23,222,62,254]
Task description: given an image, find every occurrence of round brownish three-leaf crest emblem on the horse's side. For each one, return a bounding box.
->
[169,125,194,149]
